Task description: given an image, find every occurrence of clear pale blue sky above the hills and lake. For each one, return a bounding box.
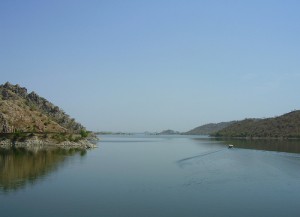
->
[0,0,300,132]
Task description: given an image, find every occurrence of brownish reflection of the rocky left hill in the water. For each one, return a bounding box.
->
[0,149,86,192]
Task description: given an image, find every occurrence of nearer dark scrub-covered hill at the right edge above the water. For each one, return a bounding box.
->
[213,110,300,138]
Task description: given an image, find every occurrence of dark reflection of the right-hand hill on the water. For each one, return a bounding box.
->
[197,138,300,153]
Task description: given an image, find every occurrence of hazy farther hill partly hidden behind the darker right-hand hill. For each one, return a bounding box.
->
[184,121,235,135]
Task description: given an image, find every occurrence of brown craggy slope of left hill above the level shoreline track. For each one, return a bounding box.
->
[0,82,85,133]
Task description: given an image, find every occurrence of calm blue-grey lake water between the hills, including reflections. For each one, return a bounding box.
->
[0,135,300,217]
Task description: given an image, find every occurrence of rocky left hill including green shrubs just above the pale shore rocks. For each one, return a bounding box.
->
[0,82,90,143]
